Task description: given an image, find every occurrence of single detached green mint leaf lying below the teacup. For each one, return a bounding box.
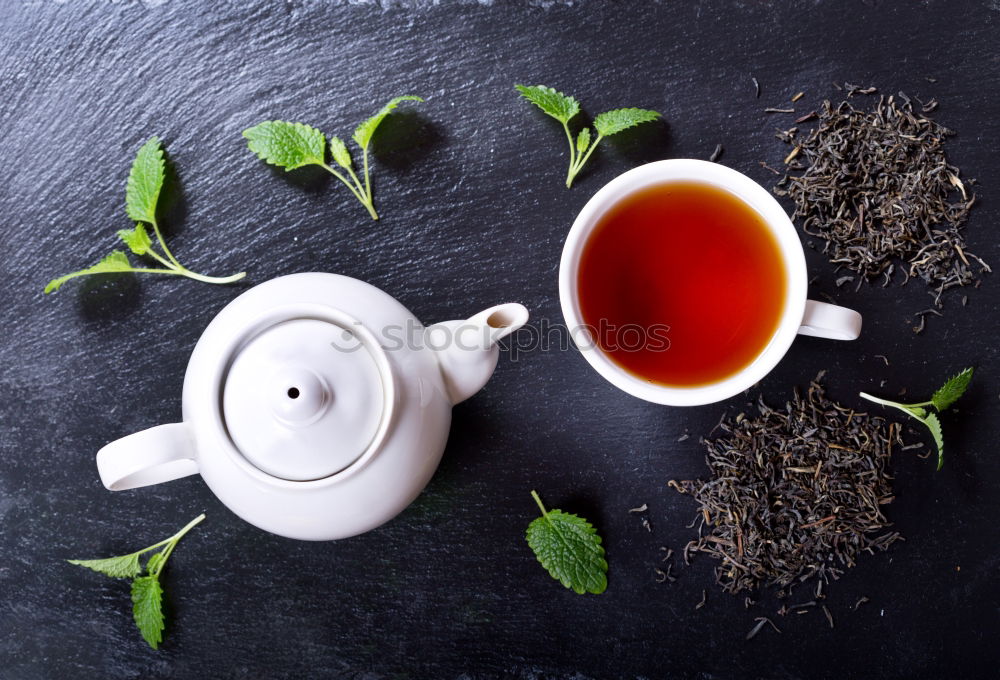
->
[526,491,608,594]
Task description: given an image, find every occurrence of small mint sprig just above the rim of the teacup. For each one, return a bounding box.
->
[514,85,660,189]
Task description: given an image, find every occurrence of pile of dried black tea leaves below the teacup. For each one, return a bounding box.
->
[669,373,902,596]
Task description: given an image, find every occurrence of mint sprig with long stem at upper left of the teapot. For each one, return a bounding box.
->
[45,137,246,293]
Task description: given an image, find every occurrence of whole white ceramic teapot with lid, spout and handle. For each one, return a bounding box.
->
[97,273,528,540]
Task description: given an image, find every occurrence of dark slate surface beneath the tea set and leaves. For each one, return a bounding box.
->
[0,0,1000,679]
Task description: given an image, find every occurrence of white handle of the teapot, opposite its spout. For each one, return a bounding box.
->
[97,423,198,491]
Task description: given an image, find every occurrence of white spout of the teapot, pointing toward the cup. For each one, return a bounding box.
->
[427,302,528,404]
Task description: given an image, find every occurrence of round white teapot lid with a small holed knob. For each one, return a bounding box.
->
[222,318,394,482]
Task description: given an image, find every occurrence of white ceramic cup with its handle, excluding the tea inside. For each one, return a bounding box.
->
[559,159,861,406]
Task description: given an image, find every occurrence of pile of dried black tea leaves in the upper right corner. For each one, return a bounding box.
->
[774,84,990,316]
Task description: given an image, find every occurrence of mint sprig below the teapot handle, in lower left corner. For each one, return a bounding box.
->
[66,514,205,649]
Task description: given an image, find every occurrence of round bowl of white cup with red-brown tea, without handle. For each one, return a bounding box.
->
[560,160,805,405]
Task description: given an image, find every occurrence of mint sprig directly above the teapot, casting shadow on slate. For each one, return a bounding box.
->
[243,95,423,220]
